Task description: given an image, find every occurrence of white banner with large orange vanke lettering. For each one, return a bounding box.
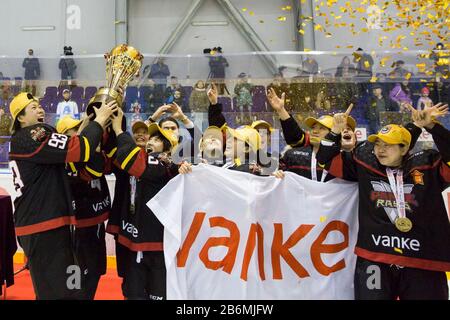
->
[147,164,358,299]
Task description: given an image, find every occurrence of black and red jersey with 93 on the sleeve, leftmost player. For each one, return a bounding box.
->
[9,121,103,236]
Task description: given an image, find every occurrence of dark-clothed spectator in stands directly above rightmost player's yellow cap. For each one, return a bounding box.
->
[365,83,393,134]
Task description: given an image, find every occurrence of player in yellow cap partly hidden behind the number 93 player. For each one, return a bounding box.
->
[56,116,111,300]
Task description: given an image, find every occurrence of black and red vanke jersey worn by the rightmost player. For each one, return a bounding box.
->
[317,124,450,271]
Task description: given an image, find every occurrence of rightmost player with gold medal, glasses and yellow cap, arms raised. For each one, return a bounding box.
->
[317,104,450,300]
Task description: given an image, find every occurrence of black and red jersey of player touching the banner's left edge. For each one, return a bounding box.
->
[116,134,178,251]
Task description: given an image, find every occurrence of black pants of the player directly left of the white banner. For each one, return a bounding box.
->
[122,251,166,300]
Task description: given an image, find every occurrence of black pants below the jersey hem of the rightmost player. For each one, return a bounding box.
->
[354,257,448,300]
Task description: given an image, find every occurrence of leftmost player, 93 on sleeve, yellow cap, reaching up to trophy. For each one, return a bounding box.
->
[9,92,117,299]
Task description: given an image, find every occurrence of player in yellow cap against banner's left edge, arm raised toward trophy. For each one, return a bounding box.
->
[112,111,178,300]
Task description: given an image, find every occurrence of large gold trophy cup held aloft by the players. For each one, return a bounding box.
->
[86,44,144,116]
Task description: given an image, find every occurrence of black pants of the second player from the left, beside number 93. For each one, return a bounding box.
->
[73,223,106,300]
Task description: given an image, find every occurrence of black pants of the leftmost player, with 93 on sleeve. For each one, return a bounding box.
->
[18,226,80,300]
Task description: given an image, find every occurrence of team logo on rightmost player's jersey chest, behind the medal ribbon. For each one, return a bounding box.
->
[370,181,418,223]
